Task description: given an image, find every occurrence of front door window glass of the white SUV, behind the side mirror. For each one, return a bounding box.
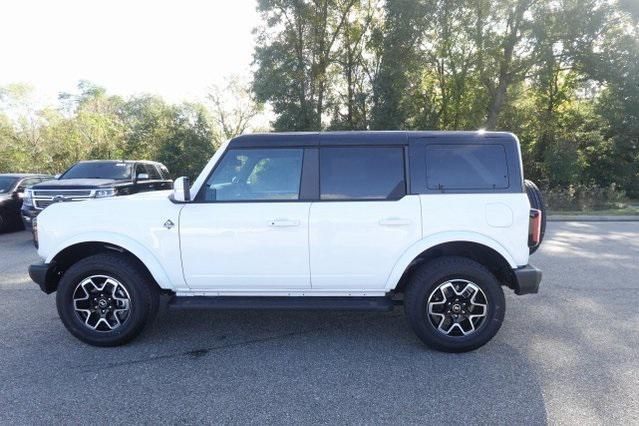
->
[204,148,304,201]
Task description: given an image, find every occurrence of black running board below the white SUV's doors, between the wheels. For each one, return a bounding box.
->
[168,296,394,311]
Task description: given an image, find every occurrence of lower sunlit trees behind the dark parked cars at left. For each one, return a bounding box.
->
[0,79,261,178]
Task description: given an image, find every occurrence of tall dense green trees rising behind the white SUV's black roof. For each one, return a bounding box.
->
[253,0,639,196]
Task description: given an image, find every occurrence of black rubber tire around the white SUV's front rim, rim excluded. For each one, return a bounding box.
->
[56,253,160,346]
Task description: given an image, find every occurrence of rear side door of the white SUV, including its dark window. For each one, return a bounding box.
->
[309,141,421,292]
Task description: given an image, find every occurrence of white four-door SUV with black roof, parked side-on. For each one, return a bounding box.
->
[29,132,545,352]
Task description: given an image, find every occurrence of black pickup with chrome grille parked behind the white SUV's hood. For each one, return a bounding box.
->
[22,160,173,229]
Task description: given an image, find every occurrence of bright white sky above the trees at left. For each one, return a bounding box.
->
[0,0,259,102]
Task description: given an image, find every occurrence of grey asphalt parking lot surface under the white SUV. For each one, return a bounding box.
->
[0,222,639,424]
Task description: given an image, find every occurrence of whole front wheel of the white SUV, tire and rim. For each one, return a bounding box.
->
[56,253,159,346]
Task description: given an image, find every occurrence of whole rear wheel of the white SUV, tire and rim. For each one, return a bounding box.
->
[404,257,506,352]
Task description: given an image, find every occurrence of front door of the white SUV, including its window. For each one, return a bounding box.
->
[180,148,310,293]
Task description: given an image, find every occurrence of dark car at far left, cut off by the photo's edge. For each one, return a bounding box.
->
[0,173,51,232]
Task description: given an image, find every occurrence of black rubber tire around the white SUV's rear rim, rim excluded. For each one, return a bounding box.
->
[404,257,506,352]
